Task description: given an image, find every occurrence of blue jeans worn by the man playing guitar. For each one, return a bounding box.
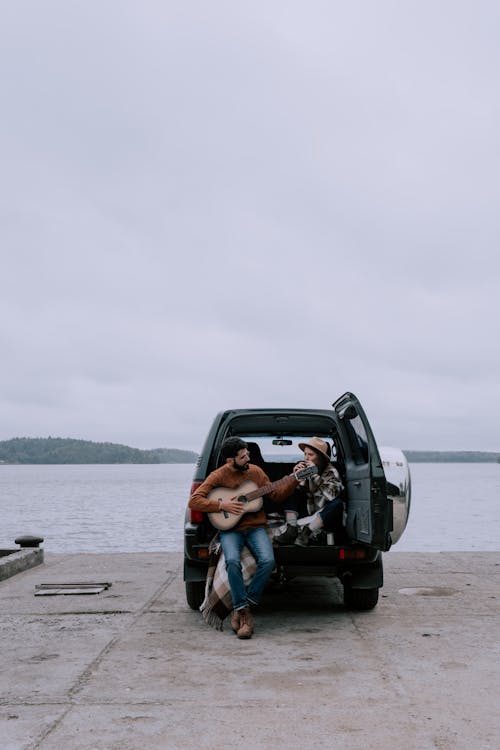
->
[220,527,274,609]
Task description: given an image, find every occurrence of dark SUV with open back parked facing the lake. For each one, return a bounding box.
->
[184,393,411,610]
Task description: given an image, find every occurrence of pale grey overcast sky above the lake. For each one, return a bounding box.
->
[0,0,500,451]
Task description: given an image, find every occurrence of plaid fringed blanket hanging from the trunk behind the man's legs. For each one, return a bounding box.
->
[200,534,257,630]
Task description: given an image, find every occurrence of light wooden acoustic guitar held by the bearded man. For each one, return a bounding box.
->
[208,466,318,531]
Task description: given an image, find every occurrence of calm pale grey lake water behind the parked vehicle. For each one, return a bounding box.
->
[0,464,500,552]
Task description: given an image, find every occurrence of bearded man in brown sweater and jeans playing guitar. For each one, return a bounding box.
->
[189,437,297,638]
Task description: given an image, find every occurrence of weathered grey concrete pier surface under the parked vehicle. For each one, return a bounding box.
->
[0,550,500,750]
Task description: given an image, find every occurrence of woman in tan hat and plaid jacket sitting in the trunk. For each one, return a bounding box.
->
[274,437,345,547]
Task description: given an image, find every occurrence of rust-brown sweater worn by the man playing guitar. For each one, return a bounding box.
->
[189,464,298,531]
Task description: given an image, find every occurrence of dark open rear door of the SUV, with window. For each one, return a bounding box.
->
[333,393,392,550]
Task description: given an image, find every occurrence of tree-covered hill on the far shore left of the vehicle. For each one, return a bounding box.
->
[0,437,198,464]
